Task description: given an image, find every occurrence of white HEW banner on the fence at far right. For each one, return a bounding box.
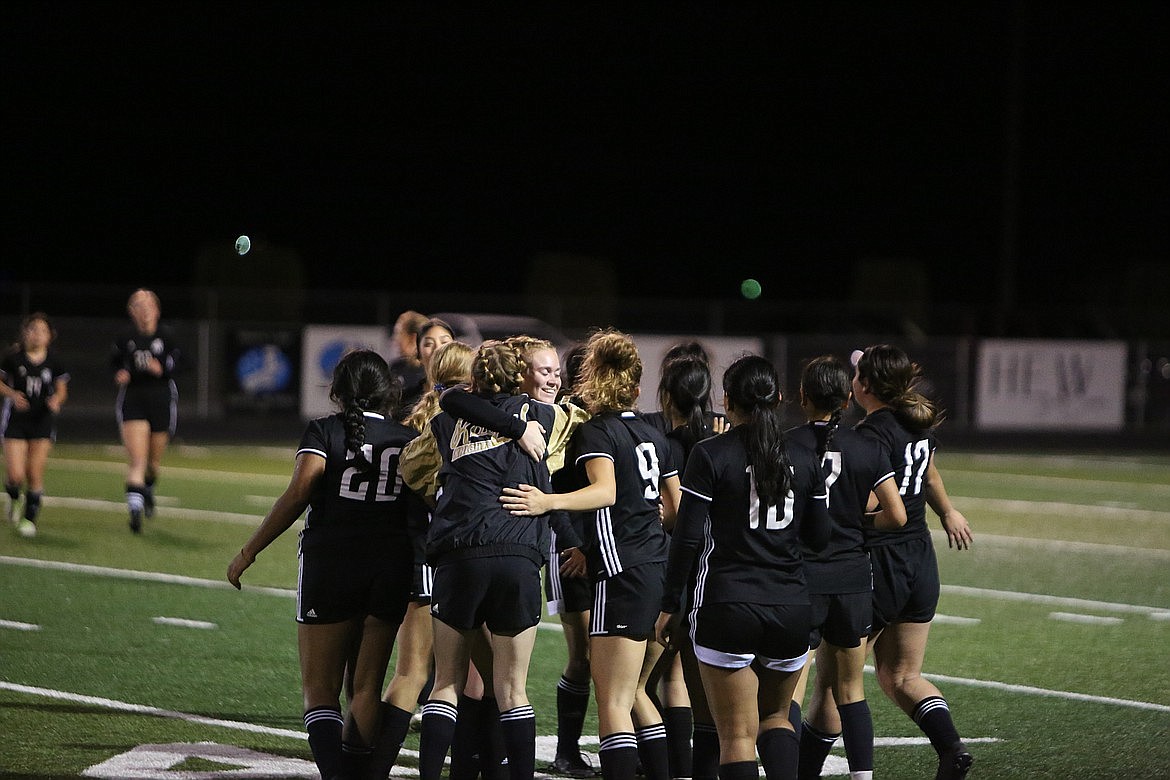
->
[975,339,1126,432]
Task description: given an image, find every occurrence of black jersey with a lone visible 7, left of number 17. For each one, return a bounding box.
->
[785,421,894,593]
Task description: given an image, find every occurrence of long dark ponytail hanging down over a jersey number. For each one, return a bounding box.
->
[723,354,792,504]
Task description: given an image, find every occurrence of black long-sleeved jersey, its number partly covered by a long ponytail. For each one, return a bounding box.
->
[662,427,830,612]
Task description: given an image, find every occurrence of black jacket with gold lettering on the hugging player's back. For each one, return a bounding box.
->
[427,395,556,566]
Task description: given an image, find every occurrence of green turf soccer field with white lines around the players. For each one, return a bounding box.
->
[0,442,1170,780]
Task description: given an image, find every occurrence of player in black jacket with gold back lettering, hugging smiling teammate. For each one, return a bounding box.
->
[419,341,555,780]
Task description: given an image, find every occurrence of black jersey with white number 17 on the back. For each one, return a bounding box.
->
[856,407,935,546]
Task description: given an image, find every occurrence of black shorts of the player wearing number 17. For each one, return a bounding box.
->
[869,537,940,631]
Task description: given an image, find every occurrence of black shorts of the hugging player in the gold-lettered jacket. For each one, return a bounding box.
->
[431,555,542,635]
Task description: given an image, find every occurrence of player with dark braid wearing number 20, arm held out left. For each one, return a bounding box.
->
[227,350,426,778]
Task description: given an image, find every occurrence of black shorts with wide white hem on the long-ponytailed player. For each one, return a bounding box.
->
[690,603,812,671]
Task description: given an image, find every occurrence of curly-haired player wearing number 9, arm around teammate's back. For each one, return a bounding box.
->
[501,331,679,780]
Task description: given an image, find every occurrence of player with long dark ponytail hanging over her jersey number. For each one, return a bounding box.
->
[656,356,830,780]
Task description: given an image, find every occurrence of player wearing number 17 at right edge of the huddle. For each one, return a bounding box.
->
[853,344,972,780]
